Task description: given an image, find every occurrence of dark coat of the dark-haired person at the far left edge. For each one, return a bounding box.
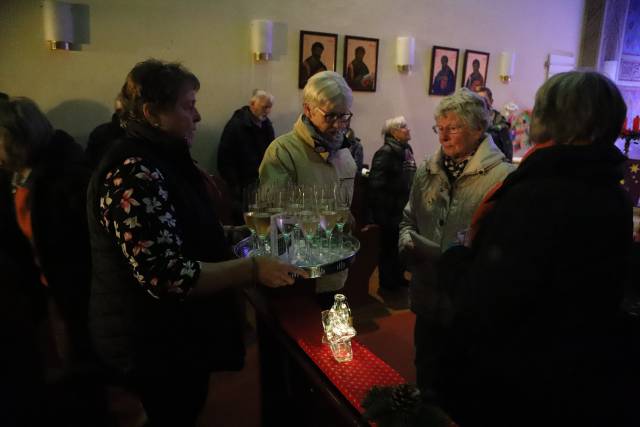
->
[27,130,91,352]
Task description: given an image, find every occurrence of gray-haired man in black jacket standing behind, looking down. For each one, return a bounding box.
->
[218,89,274,225]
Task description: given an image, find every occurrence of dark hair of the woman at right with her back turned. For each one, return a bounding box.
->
[531,71,627,144]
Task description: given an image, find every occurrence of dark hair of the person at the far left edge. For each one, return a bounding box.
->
[0,97,53,172]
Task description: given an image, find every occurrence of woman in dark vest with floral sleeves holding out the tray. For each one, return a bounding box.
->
[87,59,306,426]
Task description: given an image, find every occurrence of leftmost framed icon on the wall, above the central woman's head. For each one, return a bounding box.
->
[298,31,338,89]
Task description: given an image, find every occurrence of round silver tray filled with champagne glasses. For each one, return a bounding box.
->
[234,183,360,278]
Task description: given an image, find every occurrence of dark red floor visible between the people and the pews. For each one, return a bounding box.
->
[112,271,415,427]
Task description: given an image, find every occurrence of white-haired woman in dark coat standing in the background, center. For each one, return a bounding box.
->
[368,116,416,290]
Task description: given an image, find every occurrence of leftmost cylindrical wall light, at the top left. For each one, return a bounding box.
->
[42,0,75,50]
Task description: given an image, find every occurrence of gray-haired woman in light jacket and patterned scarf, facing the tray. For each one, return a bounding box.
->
[399,88,514,388]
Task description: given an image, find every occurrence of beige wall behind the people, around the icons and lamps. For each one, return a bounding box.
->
[0,0,584,169]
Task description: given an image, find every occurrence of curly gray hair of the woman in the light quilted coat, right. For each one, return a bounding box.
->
[434,87,489,132]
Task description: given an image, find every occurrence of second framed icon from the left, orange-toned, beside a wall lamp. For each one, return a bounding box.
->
[344,36,380,92]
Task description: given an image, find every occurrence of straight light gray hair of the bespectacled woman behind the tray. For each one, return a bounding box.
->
[302,71,353,108]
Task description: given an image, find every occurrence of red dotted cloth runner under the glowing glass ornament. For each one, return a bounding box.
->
[297,339,406,413]
